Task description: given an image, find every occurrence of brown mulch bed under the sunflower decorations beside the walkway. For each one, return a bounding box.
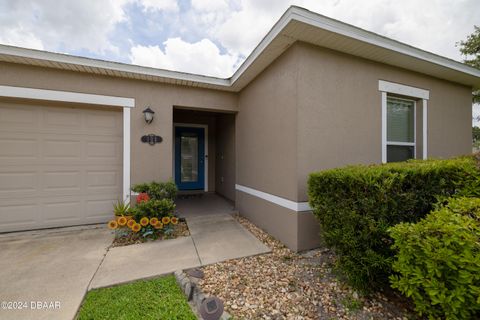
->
[111,219,190,247]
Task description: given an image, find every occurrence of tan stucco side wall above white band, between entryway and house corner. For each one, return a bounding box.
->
[236,44,298,200]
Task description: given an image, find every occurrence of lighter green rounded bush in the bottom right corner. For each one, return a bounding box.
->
[390,198,480,319]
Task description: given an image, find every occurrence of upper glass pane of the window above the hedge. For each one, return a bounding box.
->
[387,97,415,142]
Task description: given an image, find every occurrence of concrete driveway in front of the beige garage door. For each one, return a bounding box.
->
[0,228,113,319]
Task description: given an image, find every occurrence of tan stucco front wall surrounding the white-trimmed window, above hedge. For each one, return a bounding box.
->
[295,43,472,201]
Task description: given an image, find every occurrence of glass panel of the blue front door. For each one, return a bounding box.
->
[180,133,198,182]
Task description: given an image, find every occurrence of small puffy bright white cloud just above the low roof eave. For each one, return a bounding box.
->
[130,38,238,78]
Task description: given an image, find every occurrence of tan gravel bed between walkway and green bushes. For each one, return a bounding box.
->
[199,216,412,319]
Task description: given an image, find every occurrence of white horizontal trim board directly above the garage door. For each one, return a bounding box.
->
[0,86,135,108]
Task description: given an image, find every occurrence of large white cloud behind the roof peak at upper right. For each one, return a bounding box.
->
[192,0,480,60]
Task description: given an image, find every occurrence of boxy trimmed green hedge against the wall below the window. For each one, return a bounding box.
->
[308,156,480,292]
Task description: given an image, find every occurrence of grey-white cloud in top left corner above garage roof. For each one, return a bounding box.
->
[0,0,126,53]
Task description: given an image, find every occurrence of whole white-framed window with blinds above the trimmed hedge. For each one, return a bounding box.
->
[387,96,416,162]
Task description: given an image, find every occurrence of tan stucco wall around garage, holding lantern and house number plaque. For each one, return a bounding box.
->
[0,63,237,186]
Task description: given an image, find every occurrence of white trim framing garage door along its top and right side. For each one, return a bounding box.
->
[0,86,135,201]
